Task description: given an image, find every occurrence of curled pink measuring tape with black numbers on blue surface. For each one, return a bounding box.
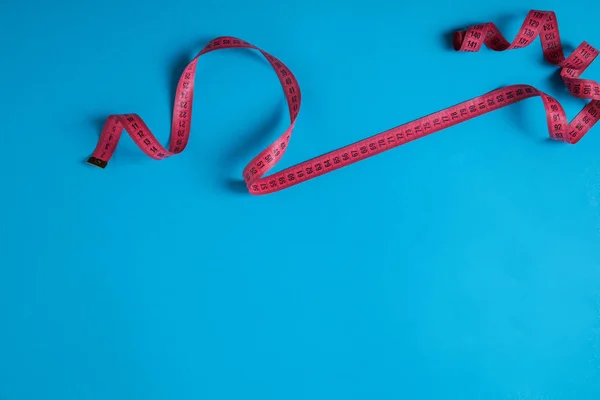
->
[88,10,600,195]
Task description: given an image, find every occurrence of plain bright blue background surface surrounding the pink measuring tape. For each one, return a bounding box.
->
[0,0,600,400]
